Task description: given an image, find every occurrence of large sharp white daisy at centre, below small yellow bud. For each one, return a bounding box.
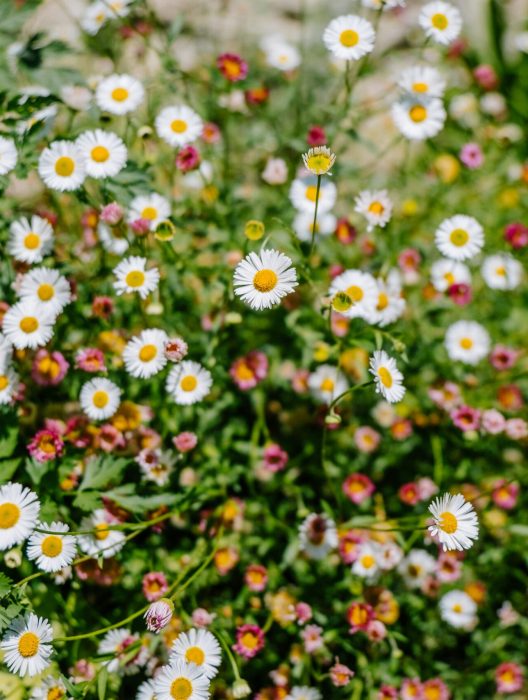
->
[233,249,298,311]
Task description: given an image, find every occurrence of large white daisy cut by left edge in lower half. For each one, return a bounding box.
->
[0,482,40,551]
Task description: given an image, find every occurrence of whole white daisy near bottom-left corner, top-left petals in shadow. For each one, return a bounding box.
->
[0,613,53,676]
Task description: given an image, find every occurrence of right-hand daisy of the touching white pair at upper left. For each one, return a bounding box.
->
[75,129,127,179]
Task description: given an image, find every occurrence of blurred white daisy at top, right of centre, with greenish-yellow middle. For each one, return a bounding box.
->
[323,15,376,61]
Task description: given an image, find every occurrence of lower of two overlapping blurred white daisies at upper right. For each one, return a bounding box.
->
[391,97,447,141]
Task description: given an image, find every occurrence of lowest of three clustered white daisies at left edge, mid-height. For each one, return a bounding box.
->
[2,300,54,350]
